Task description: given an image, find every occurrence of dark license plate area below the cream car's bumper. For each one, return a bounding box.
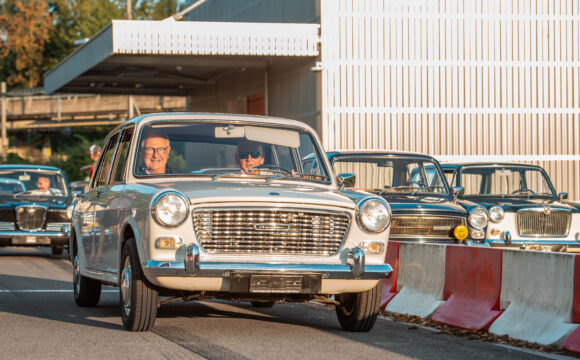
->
[230,273,322,294]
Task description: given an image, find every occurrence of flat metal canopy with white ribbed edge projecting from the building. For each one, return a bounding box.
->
[44,20,320,95]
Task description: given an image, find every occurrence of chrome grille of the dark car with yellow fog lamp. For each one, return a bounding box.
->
[391,215,465,239]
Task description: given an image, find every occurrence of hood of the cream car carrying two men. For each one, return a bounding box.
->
[139,180,360,209]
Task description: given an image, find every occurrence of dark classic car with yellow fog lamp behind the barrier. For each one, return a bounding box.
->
[328,151,488,245]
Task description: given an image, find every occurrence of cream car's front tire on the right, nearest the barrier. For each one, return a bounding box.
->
[336,281,381,332]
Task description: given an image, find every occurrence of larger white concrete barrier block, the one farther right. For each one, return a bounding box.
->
[489,250,576,345]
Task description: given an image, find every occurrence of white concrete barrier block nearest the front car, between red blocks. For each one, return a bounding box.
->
[386,242,445,317]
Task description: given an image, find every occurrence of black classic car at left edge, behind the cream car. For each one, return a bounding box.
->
[0,165,73,255]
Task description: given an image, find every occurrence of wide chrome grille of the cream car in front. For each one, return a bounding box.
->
[192,209,350,255]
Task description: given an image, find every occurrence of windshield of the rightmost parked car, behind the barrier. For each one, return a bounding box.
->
[460,166,556,197]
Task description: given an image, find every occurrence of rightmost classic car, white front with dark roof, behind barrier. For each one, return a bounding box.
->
[442,163,580,251]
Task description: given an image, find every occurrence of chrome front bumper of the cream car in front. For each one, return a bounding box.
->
[143,260,393,280]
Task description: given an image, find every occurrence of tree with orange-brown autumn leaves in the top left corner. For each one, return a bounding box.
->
[0,0,53,88]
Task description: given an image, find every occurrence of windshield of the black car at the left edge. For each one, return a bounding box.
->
[0,169,67,196]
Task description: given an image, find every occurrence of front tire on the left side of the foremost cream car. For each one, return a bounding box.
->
[119,239,158,331]
